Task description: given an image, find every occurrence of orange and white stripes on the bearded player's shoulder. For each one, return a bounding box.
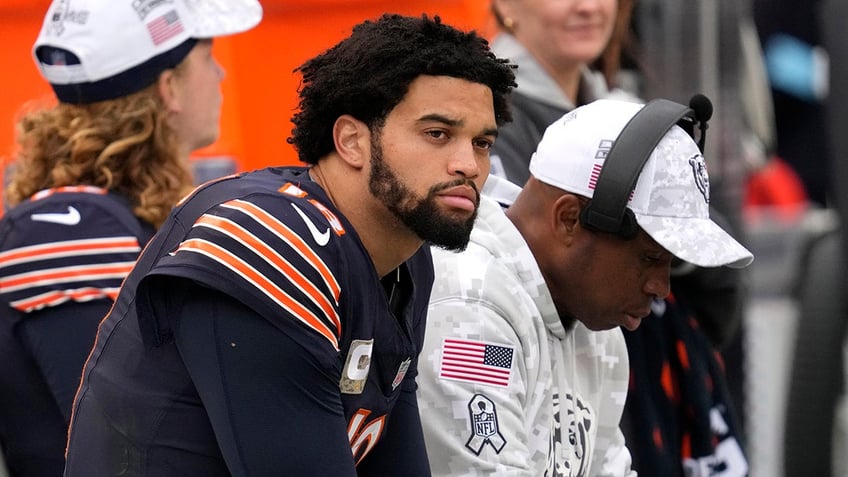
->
[177,200,342,350]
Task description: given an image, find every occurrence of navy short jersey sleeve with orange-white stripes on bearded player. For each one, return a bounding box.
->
[139,196,344,358]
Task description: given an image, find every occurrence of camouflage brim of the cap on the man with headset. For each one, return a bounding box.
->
[636,214,754,268]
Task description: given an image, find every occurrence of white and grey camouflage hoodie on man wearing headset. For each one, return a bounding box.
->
[418,178,636,477]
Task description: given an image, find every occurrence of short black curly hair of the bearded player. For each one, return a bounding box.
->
[287,14,516,164]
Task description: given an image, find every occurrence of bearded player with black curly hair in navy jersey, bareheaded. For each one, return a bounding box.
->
[65,14,515,477]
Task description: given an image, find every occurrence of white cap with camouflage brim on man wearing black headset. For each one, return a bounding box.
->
[530,99,754,268]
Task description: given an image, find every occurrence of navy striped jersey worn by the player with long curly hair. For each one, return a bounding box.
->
[0,186,153,476]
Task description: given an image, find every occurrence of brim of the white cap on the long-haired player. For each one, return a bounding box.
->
[186,0,262,38]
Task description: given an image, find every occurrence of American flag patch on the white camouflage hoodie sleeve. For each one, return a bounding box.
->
[439,338,515,387]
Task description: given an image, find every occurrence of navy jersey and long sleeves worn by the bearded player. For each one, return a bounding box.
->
[65,168,433,477]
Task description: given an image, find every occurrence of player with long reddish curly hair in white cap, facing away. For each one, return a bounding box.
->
[0,0,262,476]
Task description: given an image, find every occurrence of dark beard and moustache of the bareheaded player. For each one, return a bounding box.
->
[368,138,480,252]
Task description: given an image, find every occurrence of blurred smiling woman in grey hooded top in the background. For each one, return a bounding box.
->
[484,0,636,185]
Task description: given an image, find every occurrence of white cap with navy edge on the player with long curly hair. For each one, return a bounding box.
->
[33,0,262,103]
